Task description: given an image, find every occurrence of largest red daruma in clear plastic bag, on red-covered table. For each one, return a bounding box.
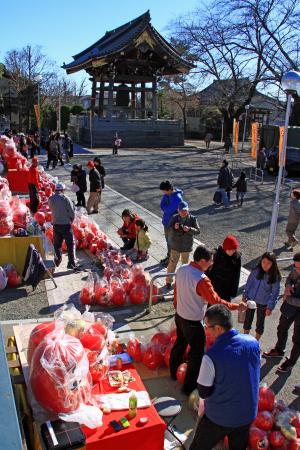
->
[29,333,91,413]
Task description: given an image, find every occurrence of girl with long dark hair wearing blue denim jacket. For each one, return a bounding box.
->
[243,252,281,340]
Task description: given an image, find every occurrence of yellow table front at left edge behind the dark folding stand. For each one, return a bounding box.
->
[0,236,45,274]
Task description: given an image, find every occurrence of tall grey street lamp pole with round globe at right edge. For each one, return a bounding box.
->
[267,70,300,252]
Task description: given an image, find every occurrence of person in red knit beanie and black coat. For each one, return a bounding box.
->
[207,235,241,302]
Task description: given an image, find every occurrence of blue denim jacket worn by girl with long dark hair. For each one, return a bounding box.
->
[244,269,280,310]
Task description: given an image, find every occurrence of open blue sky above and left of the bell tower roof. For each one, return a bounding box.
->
[0,0,199,85]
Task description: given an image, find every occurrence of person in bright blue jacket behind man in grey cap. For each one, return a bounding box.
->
[159,180,183,266]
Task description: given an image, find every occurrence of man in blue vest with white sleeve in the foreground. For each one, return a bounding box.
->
[190,304,260,450]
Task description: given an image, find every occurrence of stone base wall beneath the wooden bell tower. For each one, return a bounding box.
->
[68,116,184,148]
